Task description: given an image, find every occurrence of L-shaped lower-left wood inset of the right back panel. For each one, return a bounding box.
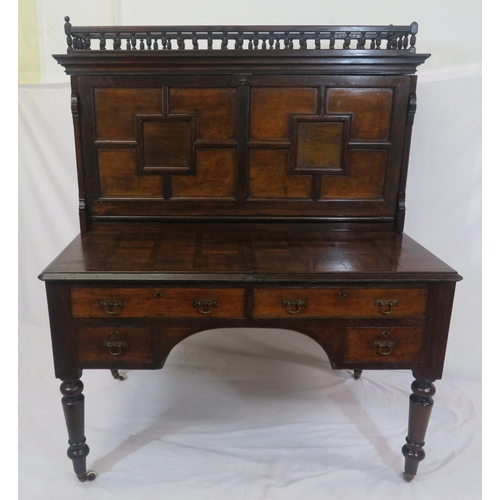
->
[249,149,311,199]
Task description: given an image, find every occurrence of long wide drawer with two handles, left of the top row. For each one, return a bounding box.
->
[71,288,245,318]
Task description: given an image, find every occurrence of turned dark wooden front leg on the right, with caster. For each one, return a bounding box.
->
[402,379,436,481]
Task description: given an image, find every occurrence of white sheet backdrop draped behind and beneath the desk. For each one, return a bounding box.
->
[19,0,481,500]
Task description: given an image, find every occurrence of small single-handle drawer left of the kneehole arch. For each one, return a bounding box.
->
[76,326,153,362]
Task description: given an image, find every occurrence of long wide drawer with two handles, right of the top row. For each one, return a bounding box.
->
[253,287,427,318]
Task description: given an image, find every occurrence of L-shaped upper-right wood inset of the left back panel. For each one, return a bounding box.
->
[169,88,236,141]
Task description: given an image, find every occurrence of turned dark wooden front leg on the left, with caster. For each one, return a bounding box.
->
[61,379,97,482]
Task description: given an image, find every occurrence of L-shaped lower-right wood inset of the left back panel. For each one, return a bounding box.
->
[171,148,236,198]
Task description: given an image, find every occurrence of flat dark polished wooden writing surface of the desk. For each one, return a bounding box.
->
[42,223,459,281]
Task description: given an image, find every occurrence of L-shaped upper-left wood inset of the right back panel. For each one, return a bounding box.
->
[250,87,318,141]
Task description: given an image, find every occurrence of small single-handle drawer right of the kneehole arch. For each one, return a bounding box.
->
[344,327,423,362]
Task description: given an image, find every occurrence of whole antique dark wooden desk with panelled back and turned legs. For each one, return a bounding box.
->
[40,18,461,481]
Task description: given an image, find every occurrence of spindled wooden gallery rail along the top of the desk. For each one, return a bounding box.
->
[64,17,418,54]
